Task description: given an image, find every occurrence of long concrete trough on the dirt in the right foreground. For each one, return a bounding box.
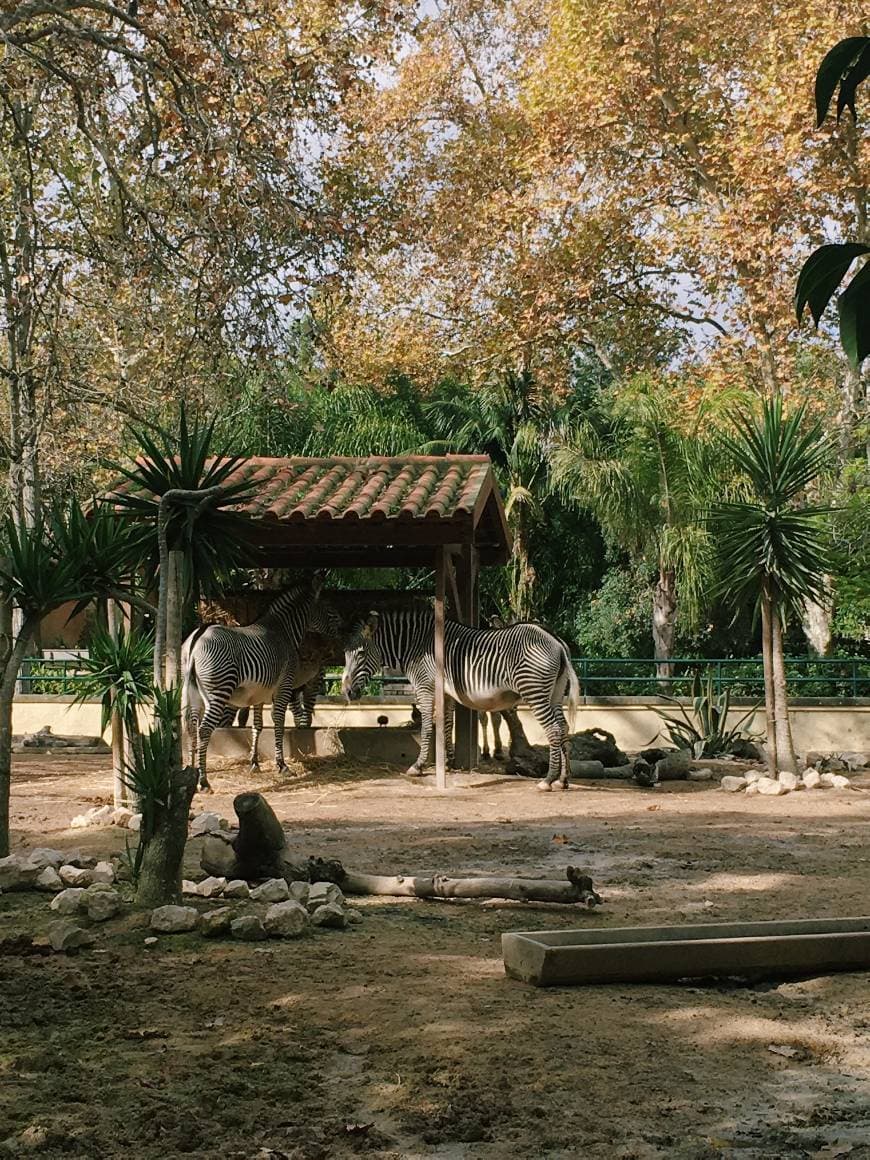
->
[501,916,870,987]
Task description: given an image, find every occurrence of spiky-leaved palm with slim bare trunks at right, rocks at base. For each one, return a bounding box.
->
[711,396,834,777]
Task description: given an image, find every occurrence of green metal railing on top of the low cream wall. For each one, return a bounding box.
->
[19,657,870,699]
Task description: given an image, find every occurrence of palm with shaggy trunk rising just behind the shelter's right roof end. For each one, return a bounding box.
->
[423,371,563,621]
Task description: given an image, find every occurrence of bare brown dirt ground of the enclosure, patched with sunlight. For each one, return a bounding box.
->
[0,754,870,1160]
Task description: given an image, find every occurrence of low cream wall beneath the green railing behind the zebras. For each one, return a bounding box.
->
[13,696,870,753]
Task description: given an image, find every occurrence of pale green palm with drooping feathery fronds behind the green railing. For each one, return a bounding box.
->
[551,376,717,681]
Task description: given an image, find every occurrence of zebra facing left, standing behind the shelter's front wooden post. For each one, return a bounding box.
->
[341,609,580,790]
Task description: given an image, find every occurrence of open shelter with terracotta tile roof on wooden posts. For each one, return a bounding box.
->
[115,455,512,786]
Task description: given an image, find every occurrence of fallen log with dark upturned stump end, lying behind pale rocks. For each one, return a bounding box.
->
[200,793,601,907]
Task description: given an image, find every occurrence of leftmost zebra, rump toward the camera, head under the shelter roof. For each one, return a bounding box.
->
[182,578,335,790]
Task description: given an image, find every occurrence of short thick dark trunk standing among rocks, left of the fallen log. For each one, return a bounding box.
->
[136,767,198,907]
